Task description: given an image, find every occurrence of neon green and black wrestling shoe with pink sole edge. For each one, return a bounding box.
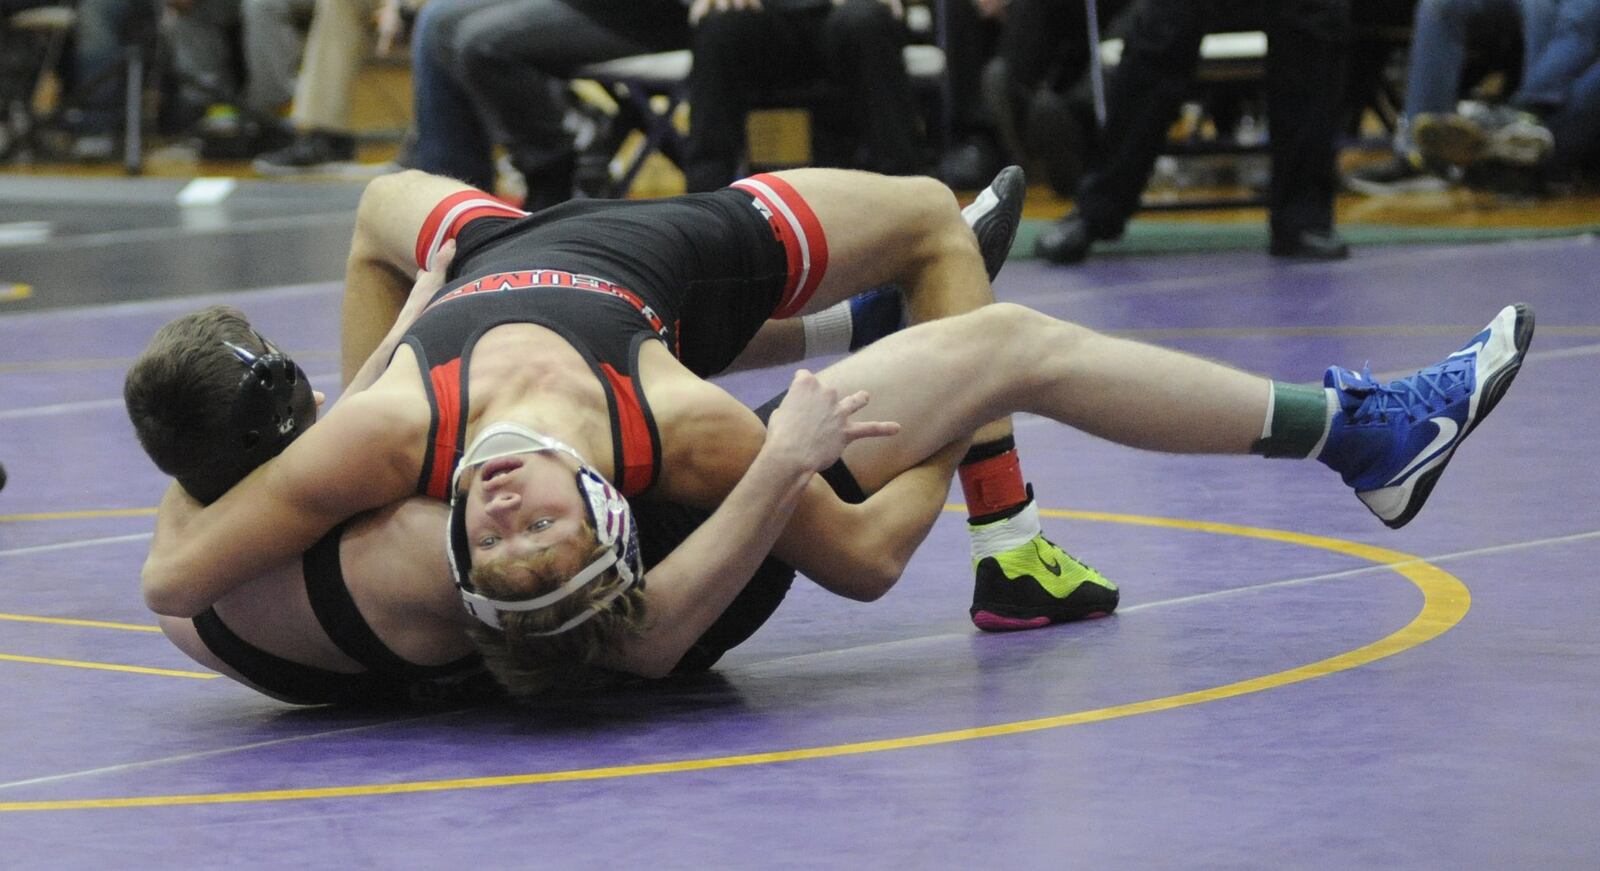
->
[970,503,1120,632]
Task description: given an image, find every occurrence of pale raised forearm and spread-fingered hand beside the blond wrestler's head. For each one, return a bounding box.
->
[606,370,899,677]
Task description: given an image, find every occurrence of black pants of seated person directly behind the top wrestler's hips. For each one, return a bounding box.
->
[685,0,922,192]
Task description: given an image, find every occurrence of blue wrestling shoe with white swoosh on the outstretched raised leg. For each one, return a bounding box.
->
[1317,304,1533,528]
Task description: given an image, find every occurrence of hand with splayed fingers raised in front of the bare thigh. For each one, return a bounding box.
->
[762,370,899,472]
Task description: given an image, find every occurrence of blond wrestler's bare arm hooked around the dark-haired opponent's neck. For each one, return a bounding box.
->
[141,389,427,616]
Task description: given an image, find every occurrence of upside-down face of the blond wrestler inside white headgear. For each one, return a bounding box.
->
[466,453,584,565]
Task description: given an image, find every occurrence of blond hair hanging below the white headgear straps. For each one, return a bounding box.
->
[467,524,646,700]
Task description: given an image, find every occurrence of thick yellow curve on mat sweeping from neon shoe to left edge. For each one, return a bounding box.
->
[0,506,1472,812]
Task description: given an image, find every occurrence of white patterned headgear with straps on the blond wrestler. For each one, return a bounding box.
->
[445,421,645,636]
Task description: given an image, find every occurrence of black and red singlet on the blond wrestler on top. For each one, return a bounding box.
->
[405,176,827,498]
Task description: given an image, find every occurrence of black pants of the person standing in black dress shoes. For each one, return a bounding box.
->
[1077,0,1350,239]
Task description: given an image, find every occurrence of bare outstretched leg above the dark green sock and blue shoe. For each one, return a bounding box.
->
[818,303,1269,492]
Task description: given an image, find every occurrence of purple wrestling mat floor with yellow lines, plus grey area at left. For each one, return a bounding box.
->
[0,176,1600,869]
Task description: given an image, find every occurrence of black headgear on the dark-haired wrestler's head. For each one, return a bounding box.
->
[178,330,317,504]
